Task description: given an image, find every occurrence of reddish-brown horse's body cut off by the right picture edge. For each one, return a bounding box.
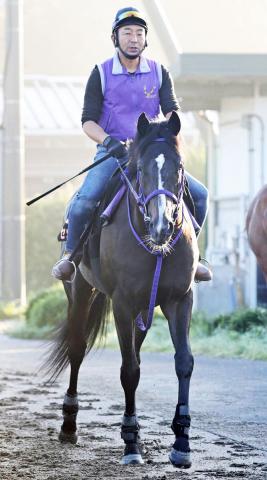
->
[246,185,267,282]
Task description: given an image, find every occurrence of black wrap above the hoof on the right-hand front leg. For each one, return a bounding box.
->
[171,405,191,452]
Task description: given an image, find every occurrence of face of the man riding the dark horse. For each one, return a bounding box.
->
[118,25,146,56]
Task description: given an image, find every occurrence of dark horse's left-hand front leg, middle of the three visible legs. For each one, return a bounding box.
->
[113,298,143,465]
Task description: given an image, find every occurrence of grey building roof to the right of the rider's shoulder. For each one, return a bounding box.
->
[170,53,267,111]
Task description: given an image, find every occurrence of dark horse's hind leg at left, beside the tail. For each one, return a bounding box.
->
[59,271,92,443]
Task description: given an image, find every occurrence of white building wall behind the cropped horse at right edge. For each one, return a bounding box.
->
[209,95,267,307]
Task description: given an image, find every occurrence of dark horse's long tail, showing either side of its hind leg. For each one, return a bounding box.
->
[41,290,111,382]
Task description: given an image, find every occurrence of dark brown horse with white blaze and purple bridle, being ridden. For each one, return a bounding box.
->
[46,112,199,467]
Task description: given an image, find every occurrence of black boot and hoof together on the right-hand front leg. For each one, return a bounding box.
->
[169,405,192,468]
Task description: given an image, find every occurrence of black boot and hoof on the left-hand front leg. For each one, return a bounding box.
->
[121,414,144,465]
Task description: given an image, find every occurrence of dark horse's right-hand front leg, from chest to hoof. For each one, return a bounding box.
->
[161,290,194,468]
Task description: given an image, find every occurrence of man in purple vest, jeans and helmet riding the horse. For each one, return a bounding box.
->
[52,7,211,281]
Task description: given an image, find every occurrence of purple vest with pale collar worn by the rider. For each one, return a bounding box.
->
[98,52,162,141]
